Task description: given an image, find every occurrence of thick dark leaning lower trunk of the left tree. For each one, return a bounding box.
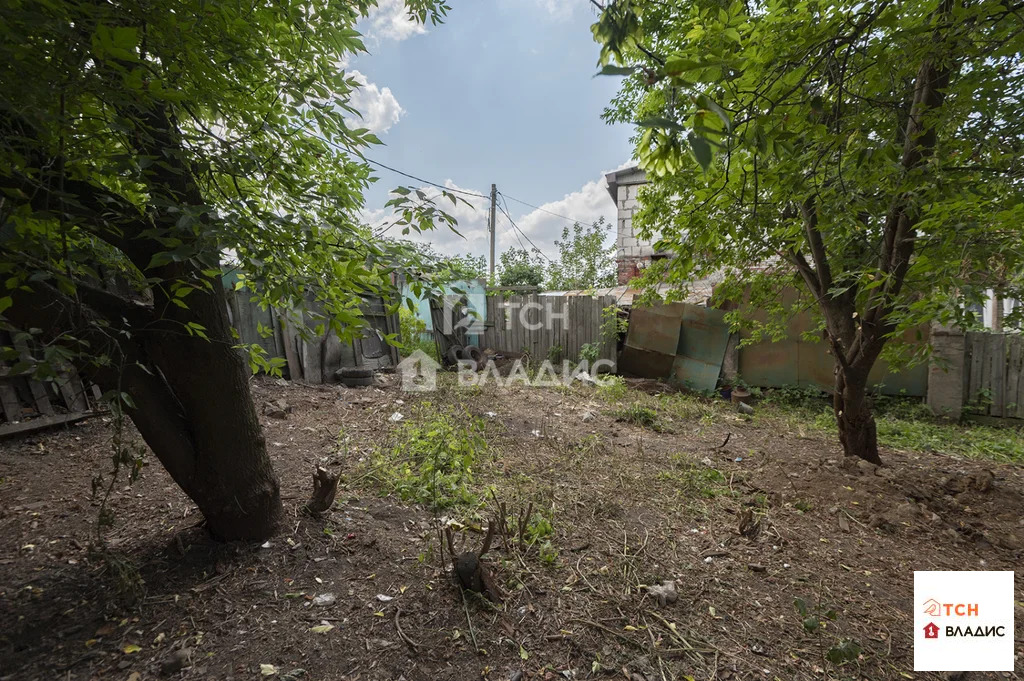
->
[0,280,283,540]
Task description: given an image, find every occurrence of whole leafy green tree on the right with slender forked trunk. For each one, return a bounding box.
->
[593,0,1024,463]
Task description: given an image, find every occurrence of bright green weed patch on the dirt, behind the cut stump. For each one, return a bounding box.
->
[372,402,487,510]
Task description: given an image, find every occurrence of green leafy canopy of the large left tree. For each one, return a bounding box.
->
[0,0,460,374]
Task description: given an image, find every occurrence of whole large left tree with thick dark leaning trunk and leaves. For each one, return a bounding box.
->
[0,0,456,539]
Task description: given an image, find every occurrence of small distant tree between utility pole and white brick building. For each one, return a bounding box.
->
[547,217,616,291]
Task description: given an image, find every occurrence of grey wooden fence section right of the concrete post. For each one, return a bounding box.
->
[964,333,1024,419]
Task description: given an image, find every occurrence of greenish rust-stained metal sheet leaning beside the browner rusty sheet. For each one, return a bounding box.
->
[672,305,729,390]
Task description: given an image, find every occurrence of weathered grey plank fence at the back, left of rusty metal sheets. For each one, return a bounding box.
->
[480,294,616,361]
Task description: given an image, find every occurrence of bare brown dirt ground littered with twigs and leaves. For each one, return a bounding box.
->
[0,379,1024,681]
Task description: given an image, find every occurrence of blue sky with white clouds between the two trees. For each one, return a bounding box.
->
[347,0,632,257]
